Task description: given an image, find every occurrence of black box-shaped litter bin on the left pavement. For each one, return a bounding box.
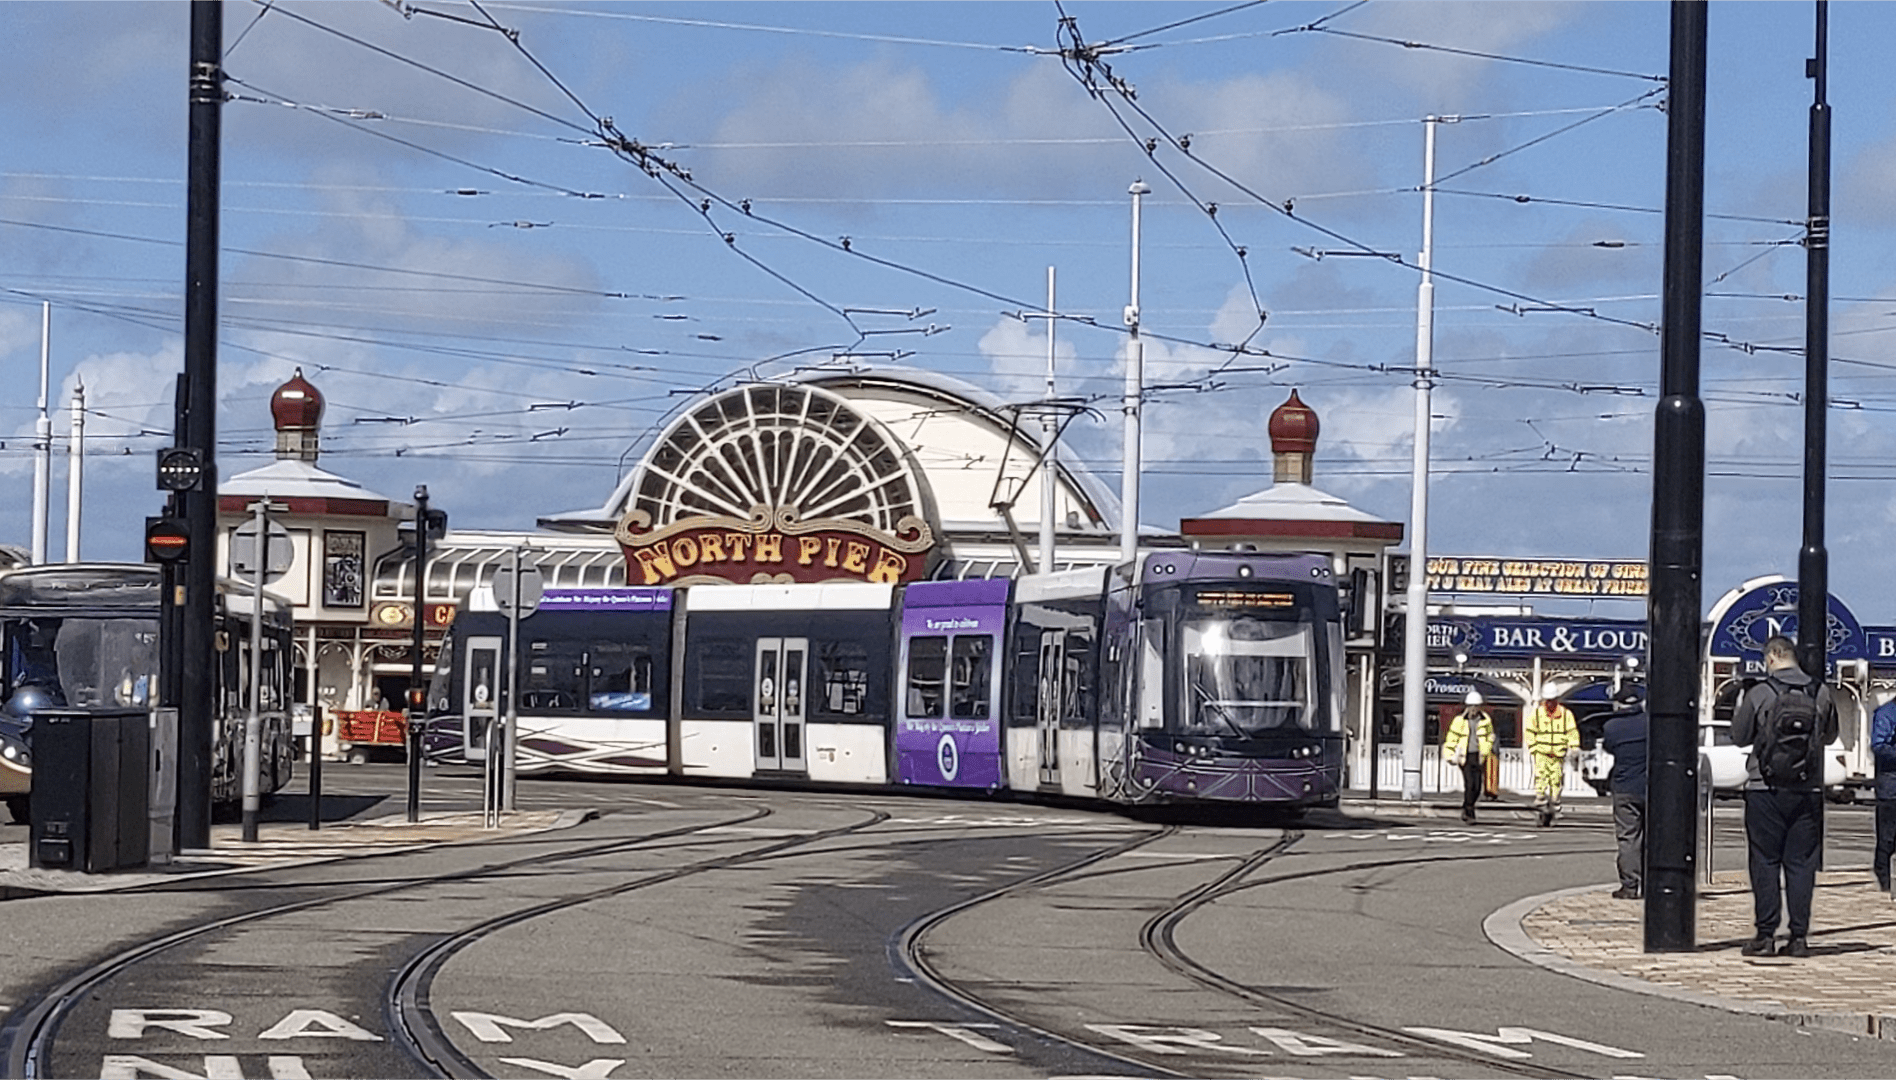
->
[27,709,152,873]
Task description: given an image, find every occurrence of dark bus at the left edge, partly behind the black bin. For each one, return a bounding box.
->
[0,563,294,820]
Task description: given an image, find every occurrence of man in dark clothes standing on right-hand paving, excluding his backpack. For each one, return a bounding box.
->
[1731,635,1837,957]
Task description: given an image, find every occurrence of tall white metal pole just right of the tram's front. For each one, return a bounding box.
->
[1403,116,1439,801]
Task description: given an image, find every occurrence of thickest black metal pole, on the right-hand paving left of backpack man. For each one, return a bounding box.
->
[1646,0,1706,953]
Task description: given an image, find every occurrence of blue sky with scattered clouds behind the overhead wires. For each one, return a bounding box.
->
[0,0,1896,621]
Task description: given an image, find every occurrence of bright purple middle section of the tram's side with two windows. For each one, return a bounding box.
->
[895,578,1012,790]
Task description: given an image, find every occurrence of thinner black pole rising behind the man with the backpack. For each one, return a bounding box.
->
[1797,0,1830,680]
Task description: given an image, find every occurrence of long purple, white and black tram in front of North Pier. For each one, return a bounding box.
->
[428,551,1344,807]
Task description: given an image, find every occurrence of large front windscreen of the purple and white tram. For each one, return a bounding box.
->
[1179,591,1318,739]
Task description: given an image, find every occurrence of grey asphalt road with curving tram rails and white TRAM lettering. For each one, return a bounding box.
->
[0,765,1896,1080]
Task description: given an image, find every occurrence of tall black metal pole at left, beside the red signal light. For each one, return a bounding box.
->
[178,0,224,849]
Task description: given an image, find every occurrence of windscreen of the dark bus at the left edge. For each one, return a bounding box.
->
[4,618,157,707]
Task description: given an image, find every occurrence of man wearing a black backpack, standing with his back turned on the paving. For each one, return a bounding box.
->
[1731,635,1837,957]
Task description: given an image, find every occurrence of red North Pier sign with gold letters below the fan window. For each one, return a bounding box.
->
[614,506,935,585]
